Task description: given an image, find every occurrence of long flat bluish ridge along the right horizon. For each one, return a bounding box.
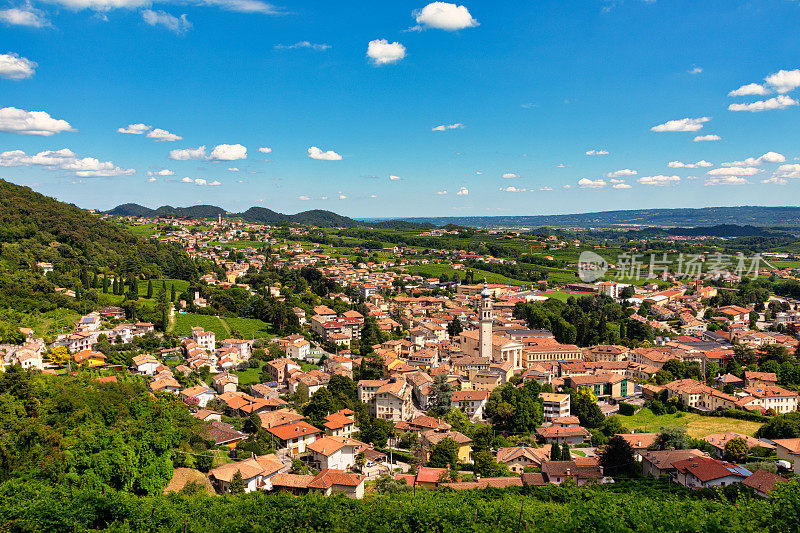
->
[390,206,800,229]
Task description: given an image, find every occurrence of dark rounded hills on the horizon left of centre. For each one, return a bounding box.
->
[106,204,434,229]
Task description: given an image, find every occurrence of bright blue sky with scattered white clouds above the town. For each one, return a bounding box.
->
[0,0,800,217]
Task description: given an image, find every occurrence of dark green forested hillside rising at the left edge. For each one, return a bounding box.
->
[0,180,197,310]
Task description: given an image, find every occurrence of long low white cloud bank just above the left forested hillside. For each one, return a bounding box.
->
[0,148,136,178]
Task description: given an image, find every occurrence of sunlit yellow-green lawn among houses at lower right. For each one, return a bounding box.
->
[620,408,761,438]
